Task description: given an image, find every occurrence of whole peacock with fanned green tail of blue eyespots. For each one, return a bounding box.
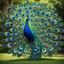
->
[0,2,64,60]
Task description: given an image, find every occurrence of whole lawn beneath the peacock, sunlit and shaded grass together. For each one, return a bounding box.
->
[0,53,64,64]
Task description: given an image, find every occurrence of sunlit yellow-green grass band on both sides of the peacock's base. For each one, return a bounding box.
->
[0,53,64,60]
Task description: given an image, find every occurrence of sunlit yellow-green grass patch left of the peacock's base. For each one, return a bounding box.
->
[0,53,29,60]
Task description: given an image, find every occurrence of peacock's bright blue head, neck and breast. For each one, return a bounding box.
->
[24,18,34,41]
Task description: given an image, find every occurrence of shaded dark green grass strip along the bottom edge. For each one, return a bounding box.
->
[0,60,64,64]
